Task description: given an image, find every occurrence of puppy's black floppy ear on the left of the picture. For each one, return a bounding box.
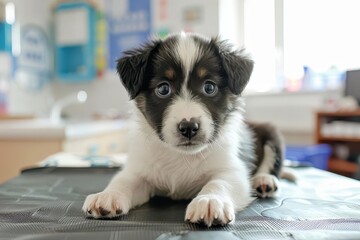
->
[116,40,160,99]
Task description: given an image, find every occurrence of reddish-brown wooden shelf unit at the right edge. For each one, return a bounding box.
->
[315,109,360,177]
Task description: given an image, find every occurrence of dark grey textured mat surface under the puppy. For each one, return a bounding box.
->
[0,168,360,240]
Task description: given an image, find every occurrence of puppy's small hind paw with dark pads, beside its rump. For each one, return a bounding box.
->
[253,173,279,198]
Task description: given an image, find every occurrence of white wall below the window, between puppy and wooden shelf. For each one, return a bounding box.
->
[245,90,342,144]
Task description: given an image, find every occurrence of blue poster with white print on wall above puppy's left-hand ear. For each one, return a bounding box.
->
[106,0,152,69]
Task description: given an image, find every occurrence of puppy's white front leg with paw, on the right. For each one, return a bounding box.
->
[185,171,253,227]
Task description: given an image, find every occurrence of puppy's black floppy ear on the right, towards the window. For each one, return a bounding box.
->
[211,38,254,95]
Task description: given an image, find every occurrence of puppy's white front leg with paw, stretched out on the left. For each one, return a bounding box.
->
[82,172,151,218]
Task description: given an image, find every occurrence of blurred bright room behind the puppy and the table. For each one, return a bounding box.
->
[0,0,360,181]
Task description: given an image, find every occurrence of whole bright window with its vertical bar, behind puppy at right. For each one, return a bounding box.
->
[244,0,360,92]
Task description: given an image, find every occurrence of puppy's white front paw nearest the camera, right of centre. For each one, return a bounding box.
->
[185,195,235,227]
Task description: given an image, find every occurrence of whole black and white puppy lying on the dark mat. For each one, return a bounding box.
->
[83,33,283,226]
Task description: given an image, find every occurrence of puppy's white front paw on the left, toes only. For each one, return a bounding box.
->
[82,190,130,218]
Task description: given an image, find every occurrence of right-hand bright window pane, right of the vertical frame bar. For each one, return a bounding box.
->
[284,0,360,90]
